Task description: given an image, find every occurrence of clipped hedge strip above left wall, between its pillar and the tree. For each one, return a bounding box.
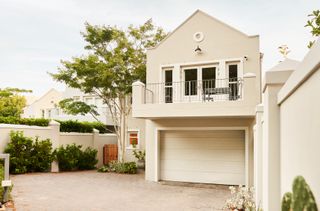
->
[55,120,113,133]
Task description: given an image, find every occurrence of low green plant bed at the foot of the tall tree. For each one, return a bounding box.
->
[98,161,137,174]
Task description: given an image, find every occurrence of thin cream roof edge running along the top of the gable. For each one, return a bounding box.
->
[148,9,259,50]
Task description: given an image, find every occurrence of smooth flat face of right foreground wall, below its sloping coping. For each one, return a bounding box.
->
[280,69,320,203]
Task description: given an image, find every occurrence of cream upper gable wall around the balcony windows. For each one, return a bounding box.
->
[147,11,261,105]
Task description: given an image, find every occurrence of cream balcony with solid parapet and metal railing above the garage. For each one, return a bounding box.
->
[132,76,260,119]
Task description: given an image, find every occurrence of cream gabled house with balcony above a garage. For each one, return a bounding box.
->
[132,10,261,185]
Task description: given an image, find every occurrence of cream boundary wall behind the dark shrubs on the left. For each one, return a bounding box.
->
[0,121,117,171]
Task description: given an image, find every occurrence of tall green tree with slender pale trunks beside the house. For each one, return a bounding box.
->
[51,19,166,161]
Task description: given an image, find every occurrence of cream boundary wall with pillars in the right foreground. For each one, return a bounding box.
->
[254,39,320,211]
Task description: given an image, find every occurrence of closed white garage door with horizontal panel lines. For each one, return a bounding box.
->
[160,130,245,185]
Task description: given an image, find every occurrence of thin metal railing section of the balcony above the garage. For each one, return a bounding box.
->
[144,78,243,104]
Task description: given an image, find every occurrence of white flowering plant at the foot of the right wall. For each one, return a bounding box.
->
[223,185,256,211]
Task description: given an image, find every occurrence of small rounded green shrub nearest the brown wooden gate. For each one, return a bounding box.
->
[79,147,98,170]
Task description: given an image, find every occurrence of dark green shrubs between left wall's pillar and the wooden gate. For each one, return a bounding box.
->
[53,144,98,171]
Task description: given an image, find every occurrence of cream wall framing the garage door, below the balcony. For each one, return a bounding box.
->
[145,118,254,185]
